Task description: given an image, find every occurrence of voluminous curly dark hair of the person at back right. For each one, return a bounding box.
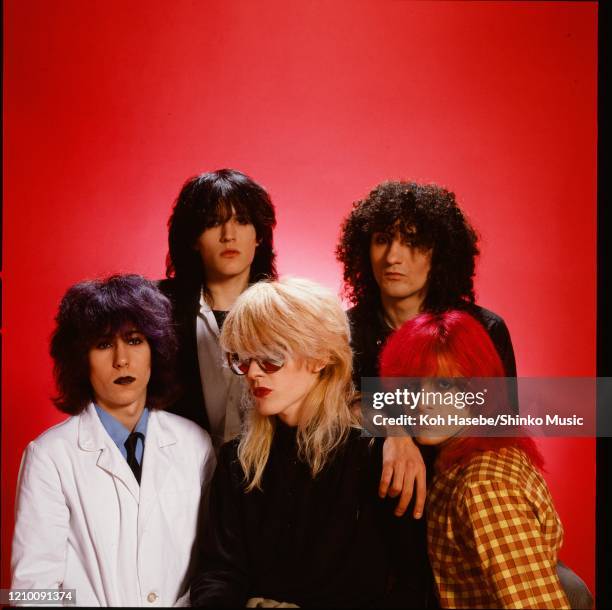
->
[336,182,479,312]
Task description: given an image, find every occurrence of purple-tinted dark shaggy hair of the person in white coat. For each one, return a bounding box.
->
[51,275,176,415]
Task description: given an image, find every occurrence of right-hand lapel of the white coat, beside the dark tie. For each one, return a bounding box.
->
[138,410,176,540]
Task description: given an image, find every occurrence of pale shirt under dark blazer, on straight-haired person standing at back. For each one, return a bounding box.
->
[196,293,247,450]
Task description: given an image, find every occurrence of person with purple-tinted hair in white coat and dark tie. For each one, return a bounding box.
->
[11,275,215,606]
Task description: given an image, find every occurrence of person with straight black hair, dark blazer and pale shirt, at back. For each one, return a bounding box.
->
[160,169,277,448]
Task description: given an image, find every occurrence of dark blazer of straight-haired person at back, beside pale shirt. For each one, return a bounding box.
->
[157,279,210,431]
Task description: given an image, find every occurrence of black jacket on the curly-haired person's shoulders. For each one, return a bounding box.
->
[347,305,516,389]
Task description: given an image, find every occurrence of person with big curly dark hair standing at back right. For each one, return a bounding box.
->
[336,181,516,516]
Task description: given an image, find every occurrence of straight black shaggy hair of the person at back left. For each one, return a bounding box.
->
[166,169,277,292]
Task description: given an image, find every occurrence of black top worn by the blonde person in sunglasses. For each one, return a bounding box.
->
[191,422,430,608]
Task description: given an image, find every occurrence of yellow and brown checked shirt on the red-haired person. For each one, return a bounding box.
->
[427,447,570,608]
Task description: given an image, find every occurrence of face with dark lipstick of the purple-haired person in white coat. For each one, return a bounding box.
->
[89,328,151,414]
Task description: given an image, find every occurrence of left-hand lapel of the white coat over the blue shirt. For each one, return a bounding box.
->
[79,403,140,502]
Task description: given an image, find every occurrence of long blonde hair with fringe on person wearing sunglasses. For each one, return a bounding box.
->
[220,278,355,491]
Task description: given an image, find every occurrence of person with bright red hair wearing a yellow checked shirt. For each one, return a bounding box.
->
[380,310,570,608]
